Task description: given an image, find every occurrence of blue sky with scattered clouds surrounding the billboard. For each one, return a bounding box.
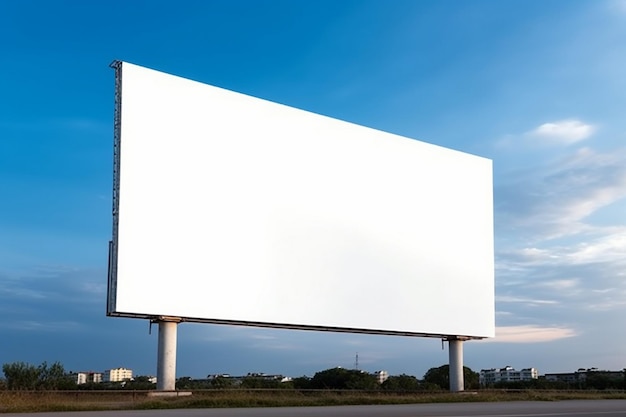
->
[0,0,626,377]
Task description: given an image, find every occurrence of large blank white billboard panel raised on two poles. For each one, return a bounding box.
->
[108,63,494,338]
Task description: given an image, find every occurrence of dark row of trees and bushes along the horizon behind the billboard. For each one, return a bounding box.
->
[0,362,626,392]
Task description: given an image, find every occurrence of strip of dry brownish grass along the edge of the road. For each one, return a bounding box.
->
[0,389,626,413]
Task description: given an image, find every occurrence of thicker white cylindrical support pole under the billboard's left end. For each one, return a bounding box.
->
[154,317,181,391]
